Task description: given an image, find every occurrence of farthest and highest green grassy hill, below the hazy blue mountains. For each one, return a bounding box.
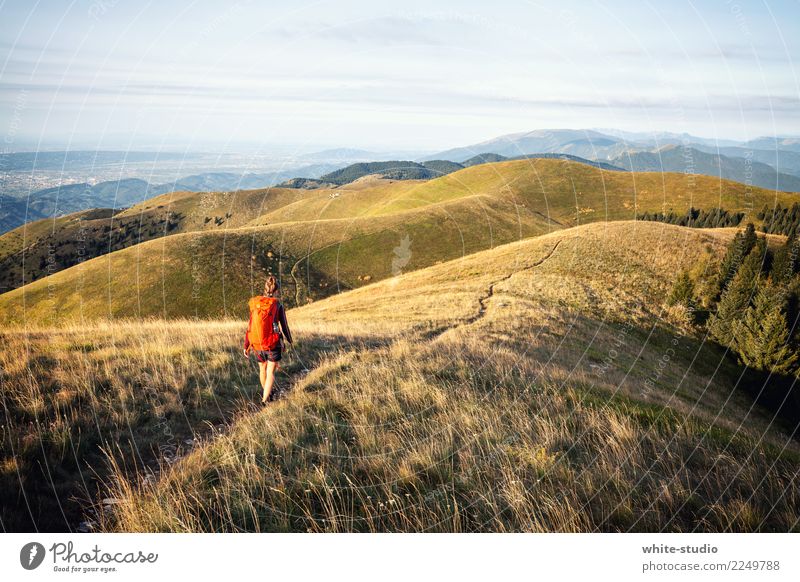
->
[251,159,797,226]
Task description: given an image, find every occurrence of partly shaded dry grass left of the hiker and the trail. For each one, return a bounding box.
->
[0,321,257,531]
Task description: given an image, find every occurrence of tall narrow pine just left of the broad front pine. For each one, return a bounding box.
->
[708,239,766,347]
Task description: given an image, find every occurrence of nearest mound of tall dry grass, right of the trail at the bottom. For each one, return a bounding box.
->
[98,341,800,531]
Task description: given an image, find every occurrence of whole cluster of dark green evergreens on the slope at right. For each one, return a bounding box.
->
[668,224,800,394]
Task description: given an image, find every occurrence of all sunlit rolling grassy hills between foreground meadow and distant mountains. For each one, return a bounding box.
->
[0,159,796,323]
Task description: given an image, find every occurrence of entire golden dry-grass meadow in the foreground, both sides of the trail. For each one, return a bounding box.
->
[0,221,800,531]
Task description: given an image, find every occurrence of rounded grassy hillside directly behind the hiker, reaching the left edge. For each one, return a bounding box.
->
[0,195,547,325]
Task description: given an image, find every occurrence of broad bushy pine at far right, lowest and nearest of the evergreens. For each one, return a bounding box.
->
[731,284,797,374]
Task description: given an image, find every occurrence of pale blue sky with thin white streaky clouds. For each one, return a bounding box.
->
[0,0,800,152]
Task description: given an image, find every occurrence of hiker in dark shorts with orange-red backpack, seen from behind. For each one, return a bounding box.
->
[244,275,292,404]
